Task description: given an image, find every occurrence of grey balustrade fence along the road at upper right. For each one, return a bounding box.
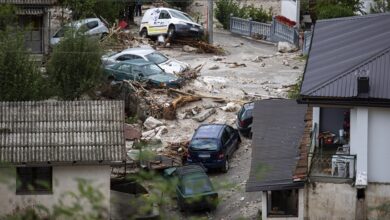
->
[230,17,299,45]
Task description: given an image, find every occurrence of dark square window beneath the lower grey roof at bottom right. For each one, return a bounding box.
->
[267,189,299,217]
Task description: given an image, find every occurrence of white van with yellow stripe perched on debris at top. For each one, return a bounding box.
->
[139,8,204,37]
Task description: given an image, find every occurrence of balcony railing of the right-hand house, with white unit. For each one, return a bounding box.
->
[309,153,356,179]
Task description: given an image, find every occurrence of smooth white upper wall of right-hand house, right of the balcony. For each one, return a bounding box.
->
[350,107,390,185]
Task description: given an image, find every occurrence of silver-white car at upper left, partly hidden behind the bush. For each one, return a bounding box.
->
[50,18,108,45]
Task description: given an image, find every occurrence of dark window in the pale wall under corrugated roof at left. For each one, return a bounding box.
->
[16,167,52,195]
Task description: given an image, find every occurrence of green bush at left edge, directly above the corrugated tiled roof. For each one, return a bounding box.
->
[0,28,48,101]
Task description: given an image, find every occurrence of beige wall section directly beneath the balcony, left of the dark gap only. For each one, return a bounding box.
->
[306,182,356,220]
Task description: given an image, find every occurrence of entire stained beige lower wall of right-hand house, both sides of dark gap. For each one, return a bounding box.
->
[306,182,390,220]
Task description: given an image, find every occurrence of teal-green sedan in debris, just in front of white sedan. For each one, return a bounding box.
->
[104,59,182,87]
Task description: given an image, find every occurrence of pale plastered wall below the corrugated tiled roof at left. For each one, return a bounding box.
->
[0,165,111,215]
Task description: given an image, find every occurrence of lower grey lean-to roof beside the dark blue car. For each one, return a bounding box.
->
[246,100,307,191]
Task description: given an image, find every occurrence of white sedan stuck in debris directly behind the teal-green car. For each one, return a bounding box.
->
[101,48,190,74]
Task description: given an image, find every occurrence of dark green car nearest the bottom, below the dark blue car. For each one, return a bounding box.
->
[168,165,218,211]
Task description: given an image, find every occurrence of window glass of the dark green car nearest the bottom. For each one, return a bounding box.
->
[182,174,213,195]
